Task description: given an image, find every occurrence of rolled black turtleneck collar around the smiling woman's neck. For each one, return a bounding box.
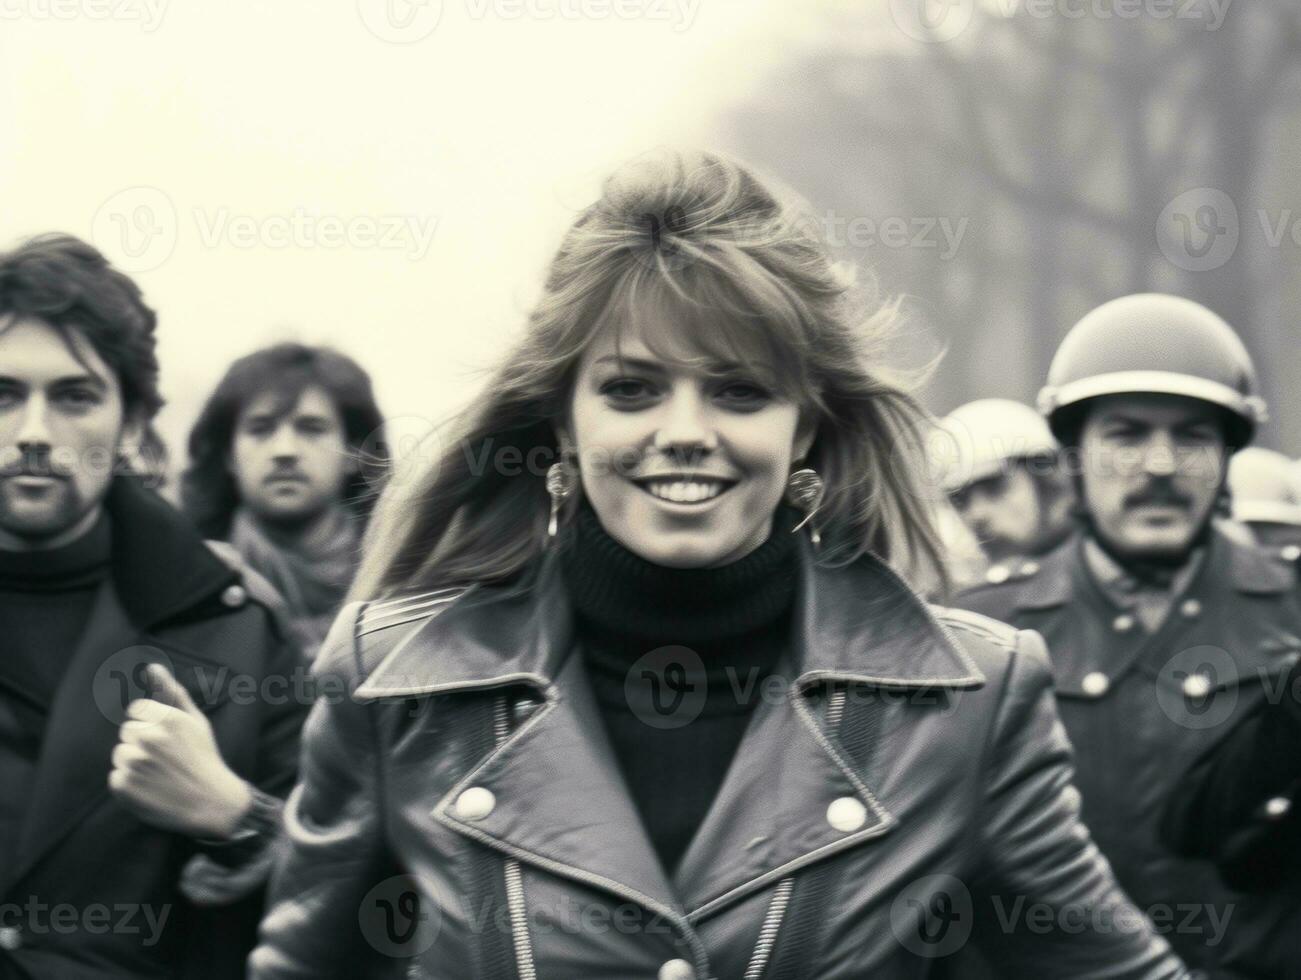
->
[562,505,796,652]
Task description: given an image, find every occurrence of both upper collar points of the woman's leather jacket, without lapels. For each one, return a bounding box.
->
[356,530,985,700]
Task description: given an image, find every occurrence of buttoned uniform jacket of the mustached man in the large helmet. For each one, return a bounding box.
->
[958,531,1301,977]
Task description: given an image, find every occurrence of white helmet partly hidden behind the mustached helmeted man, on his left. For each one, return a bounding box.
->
[934,398,1058,493]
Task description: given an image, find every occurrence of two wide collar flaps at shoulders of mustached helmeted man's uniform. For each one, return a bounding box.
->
[1016,527,1296,609]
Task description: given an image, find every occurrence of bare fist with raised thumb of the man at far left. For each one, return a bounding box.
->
[108,664,252,839]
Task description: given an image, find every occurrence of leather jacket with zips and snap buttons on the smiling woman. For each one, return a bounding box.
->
[251,544,1181,980]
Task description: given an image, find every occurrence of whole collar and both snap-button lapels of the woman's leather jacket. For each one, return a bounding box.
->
[355,545,985,946]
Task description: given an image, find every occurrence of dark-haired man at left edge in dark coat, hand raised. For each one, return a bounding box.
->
[0,236,310,980]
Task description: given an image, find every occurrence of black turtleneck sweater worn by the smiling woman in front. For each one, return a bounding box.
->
[563,506,795,873]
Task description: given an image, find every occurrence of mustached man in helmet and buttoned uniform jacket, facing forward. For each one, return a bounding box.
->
[958,294,1301,980]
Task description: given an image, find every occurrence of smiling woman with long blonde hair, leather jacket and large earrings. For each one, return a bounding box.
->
[251,154,1180,980]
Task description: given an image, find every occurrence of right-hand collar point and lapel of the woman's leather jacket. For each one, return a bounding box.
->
[674,546,985,920]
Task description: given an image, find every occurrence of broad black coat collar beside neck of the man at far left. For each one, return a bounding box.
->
[104,476,238,629]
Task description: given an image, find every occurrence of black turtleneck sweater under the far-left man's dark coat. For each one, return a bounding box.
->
[0,517,111,867]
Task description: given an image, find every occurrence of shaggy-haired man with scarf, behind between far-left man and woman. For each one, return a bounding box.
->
[182,344,388,659]
